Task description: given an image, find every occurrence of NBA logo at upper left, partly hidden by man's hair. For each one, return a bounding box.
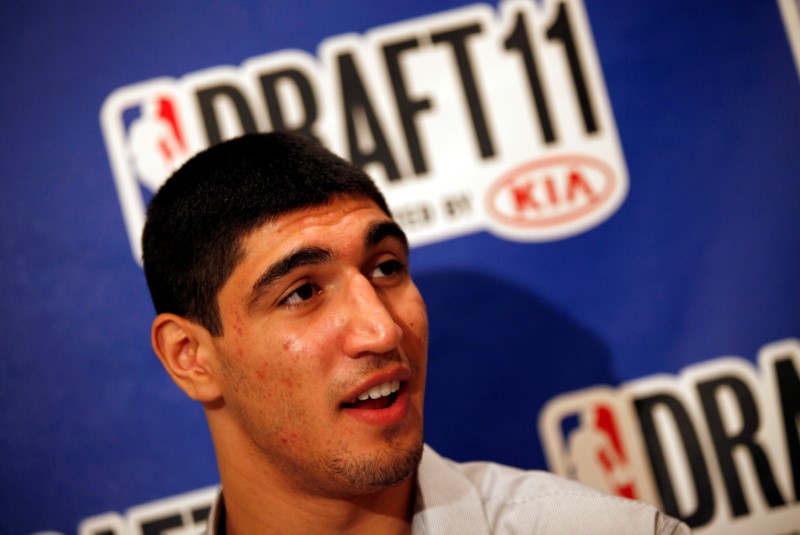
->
[100,78,202,262]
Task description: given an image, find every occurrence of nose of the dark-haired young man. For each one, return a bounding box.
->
[344,273,403,358]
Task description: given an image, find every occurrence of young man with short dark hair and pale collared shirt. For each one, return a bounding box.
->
[143,133,688,535]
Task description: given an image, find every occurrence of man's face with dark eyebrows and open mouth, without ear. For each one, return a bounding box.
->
[213,197,428,496]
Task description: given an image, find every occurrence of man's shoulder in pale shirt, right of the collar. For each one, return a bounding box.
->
[418,449,689,535]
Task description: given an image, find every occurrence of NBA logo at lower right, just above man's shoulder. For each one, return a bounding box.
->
[539,387,656,503]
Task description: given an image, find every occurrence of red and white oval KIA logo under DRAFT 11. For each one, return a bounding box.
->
[486,155,620,229]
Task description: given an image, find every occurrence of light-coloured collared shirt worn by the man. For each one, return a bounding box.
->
[208,445,691,535]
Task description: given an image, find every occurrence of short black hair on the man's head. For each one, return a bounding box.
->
[142,132,391,336]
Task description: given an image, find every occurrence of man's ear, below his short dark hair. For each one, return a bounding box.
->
[152,314,222,403]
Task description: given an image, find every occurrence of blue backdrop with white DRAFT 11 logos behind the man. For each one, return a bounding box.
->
[0,0,800,535]
